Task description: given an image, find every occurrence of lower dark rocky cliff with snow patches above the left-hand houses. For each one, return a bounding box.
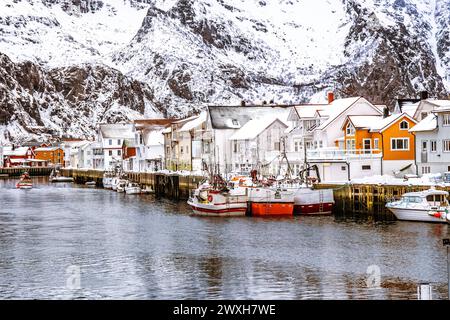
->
[0,54,162,142]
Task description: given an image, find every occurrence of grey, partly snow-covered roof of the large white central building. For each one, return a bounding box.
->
[208,105,292,129]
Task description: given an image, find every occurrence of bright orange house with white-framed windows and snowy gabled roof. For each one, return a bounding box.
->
[341,113,417,174]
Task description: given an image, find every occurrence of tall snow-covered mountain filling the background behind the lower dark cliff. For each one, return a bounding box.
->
[0,0,450,142]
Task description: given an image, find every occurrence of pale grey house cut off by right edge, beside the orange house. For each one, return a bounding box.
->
[410,100,450,175]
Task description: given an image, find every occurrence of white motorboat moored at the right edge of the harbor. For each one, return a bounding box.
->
[386,188,450,223]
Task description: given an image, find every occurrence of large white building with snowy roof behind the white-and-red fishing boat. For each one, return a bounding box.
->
[203,104,292,174]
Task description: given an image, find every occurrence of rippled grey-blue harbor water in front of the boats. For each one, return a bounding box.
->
[0,178,450,299]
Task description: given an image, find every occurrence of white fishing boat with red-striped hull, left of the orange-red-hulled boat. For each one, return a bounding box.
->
[188,175,248,217]
